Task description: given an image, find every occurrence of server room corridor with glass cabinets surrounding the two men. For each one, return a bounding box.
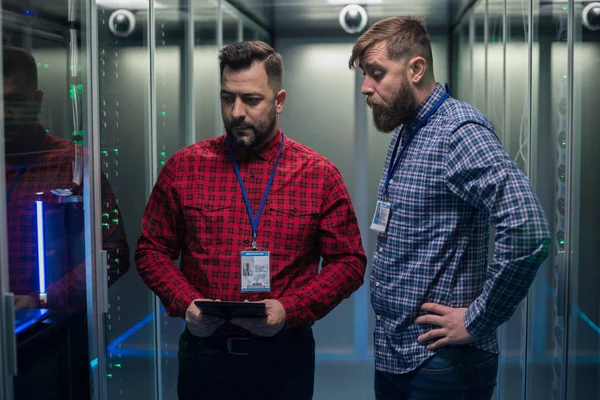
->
[0,0,600,400]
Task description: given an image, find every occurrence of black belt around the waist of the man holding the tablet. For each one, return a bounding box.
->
[183,325,314,356]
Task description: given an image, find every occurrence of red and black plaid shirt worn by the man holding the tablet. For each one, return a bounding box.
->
[136,126,366,335]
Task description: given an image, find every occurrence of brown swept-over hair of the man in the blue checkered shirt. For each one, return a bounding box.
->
[349,16,433,69]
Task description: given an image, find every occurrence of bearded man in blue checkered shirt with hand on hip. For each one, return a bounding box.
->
[350,17,550,400]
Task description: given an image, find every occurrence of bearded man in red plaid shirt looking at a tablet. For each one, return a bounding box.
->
[136,41,366,400]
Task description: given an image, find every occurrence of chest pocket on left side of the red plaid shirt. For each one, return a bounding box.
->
[182,200,232,250]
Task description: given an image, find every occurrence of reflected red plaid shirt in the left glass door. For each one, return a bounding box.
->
[6,127,129,311]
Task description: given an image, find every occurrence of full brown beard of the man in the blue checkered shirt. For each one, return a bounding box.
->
[367,82,416,133]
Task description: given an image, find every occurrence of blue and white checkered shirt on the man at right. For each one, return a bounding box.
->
[370,84,550,374]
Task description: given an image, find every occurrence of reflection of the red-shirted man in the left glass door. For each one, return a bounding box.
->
[3,46,129,313]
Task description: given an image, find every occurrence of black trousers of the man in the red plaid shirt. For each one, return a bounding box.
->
[177,326,315,400]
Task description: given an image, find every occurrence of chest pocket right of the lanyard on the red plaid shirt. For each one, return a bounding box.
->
[269,204,320,253]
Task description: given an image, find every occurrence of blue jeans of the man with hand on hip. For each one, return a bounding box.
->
[375,346,498,400]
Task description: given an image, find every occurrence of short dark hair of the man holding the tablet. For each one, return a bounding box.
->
[219,40,283,92]
